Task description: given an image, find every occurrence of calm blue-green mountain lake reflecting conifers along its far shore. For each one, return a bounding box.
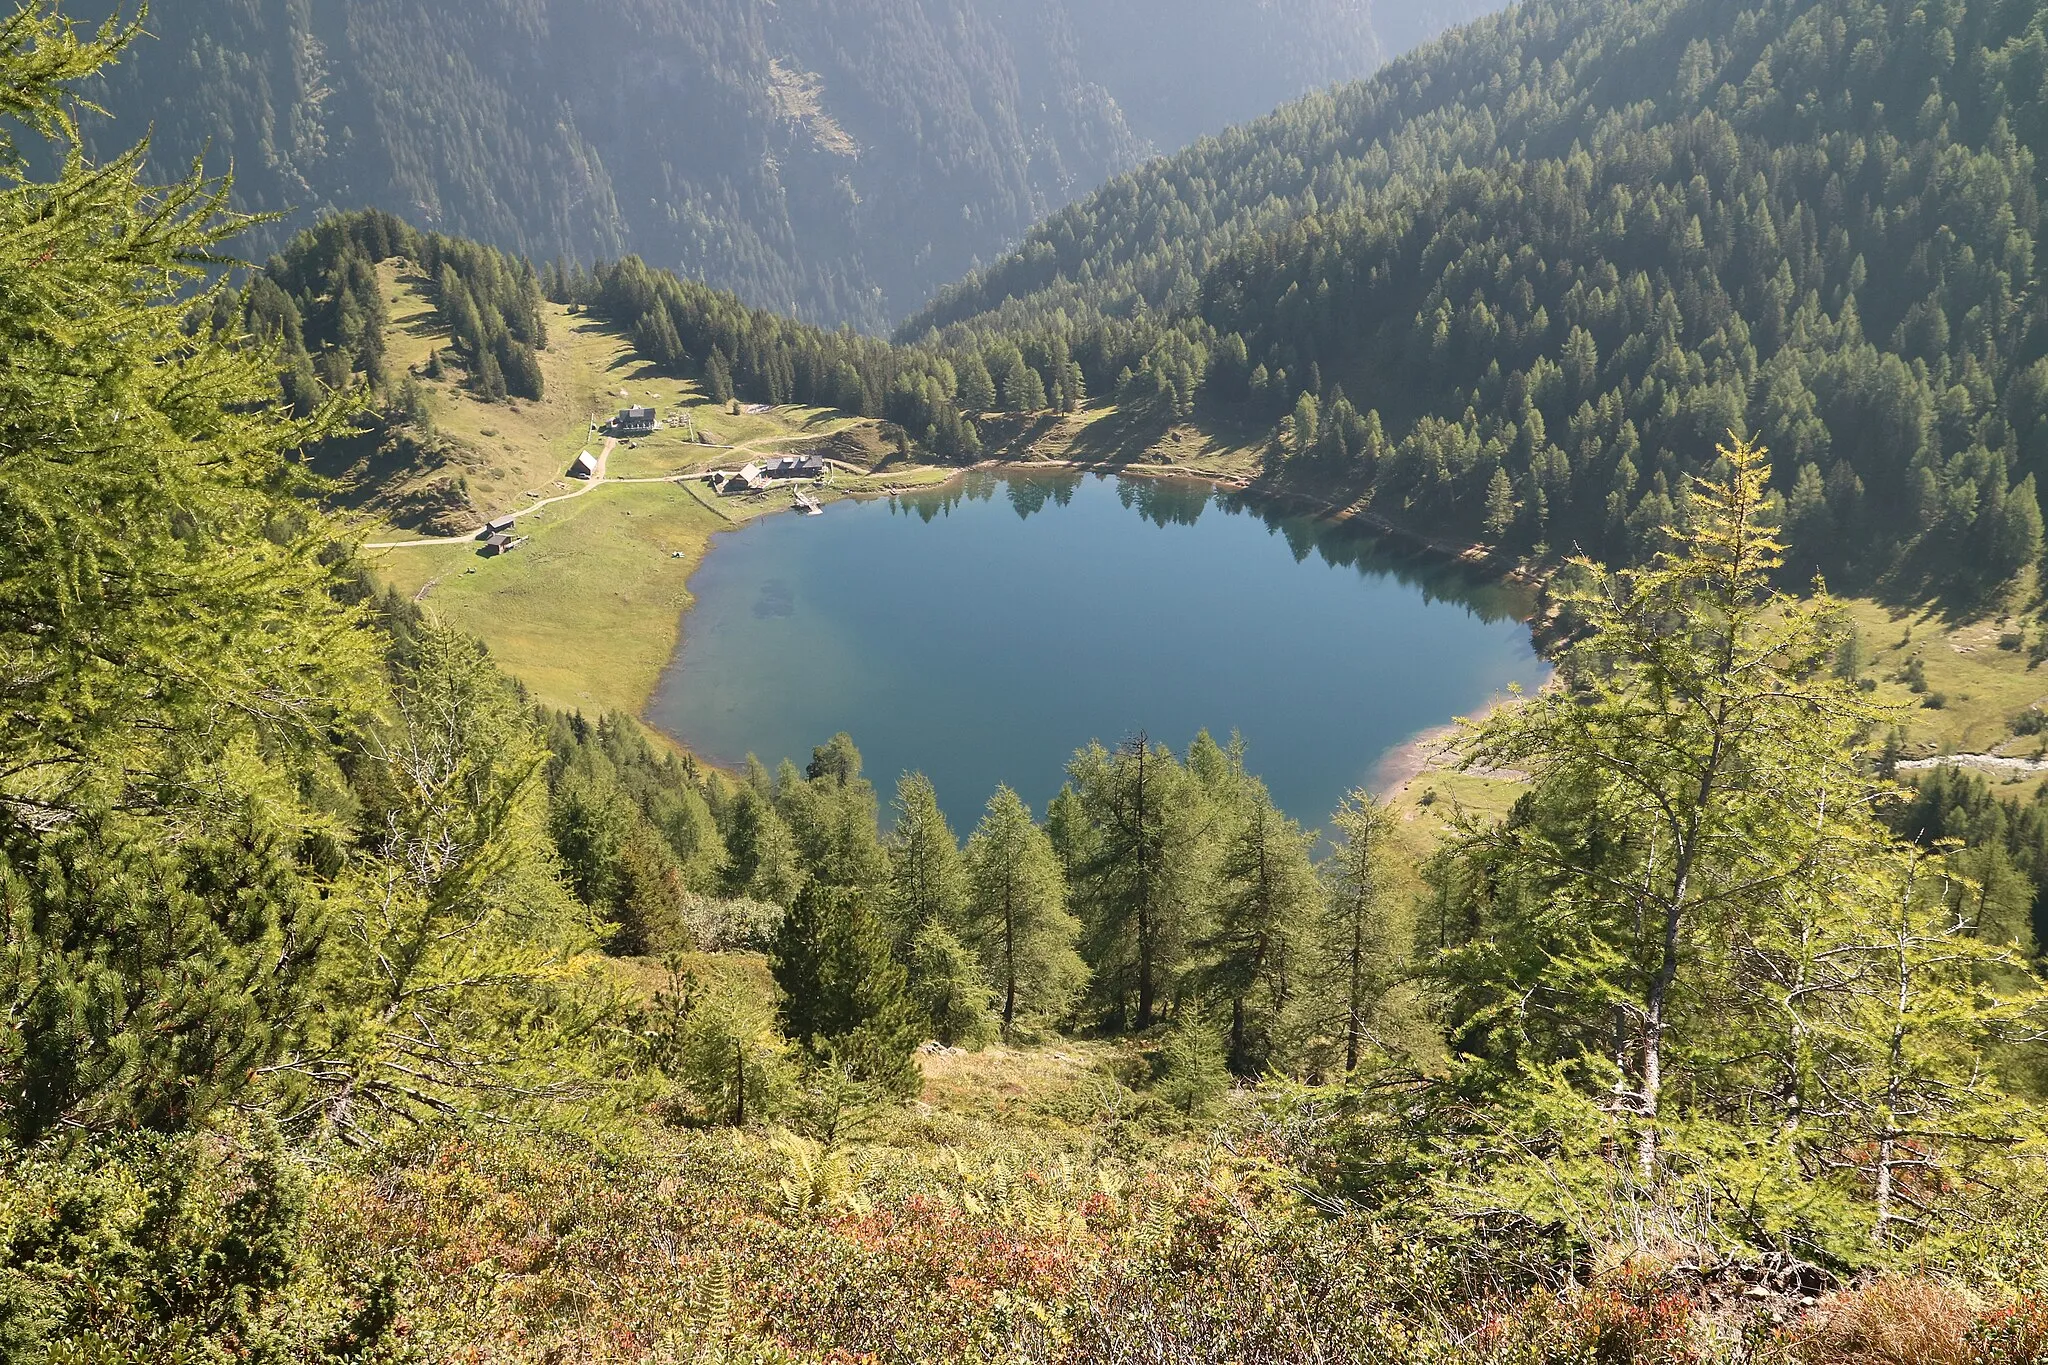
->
[649,473,1548,837]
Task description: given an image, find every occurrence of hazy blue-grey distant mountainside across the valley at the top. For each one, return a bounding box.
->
[59,0,1485,327]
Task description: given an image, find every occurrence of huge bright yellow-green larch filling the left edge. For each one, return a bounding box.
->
[0,2,375,1142]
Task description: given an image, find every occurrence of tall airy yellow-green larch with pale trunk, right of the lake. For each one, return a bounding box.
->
[1440,438,1874,1183]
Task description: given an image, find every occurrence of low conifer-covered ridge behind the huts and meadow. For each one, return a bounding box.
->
[218,209,993,530]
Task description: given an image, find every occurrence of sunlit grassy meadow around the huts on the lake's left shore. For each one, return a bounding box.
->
[360,262,966,714]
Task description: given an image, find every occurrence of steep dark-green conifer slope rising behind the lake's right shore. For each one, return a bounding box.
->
[905,0,2048,593]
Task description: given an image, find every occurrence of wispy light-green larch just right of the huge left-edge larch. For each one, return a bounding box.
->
[266,622,598,1142]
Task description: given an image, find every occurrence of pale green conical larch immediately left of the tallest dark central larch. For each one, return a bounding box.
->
[967,786,1087,1042]
